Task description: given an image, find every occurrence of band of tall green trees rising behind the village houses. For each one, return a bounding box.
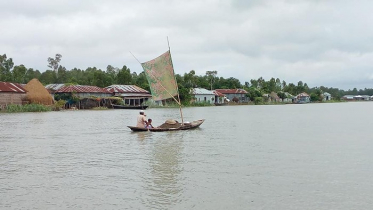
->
[0,54,373,101]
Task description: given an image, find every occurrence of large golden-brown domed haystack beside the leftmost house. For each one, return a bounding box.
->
[24,79,54,105]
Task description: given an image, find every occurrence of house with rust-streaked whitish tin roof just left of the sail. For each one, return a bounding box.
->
[105,85,152,106]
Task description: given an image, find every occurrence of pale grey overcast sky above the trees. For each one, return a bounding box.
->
[0,0,373,90]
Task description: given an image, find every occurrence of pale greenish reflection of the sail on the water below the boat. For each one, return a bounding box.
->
[143,132,183,209]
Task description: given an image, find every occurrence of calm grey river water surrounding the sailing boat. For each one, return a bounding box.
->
[0,102,373,210]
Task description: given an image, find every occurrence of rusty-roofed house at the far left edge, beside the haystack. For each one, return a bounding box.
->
[0,82,27,106]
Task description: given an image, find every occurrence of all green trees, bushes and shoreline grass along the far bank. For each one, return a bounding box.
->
[0,54,373,113]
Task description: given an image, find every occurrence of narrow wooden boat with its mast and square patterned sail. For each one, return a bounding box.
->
[128,41,205,132]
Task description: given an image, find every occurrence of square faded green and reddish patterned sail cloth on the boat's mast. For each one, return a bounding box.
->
[141,51,177,101]
